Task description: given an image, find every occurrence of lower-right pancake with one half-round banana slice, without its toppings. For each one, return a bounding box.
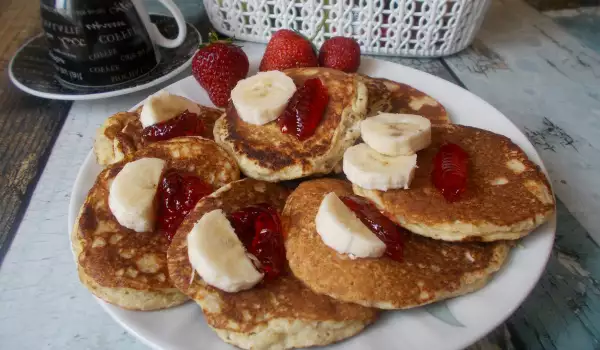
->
[282,179,509,309]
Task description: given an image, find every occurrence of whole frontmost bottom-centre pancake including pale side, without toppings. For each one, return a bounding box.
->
[168,178,376,349]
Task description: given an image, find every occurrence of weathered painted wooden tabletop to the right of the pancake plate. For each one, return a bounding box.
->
[444,0,600,350]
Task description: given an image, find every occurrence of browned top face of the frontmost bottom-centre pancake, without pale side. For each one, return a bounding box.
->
[168,178,376,334]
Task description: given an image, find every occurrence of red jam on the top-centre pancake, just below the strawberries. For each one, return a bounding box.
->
[277,78,329,141]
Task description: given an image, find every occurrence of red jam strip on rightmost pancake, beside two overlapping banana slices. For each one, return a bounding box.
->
[431,143,469,202]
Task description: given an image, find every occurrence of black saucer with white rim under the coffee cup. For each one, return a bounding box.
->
[8,14,202,101]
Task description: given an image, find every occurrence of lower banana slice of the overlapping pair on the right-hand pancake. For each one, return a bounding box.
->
[342,143,417,191]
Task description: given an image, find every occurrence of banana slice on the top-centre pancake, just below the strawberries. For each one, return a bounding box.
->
[231,71,296,125]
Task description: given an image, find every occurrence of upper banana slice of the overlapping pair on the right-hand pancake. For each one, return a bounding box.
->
[360,113,431,156]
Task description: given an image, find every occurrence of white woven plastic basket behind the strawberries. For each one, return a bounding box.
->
[204,0,491,57]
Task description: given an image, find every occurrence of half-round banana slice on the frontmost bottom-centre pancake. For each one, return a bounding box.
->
[187,209,263,293]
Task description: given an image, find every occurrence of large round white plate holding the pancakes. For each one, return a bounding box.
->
[69,50,556,350]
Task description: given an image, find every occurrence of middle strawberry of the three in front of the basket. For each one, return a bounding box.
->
[259,29,319,72]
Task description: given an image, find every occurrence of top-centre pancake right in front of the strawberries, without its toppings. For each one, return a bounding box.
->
[214,68,367,182]
